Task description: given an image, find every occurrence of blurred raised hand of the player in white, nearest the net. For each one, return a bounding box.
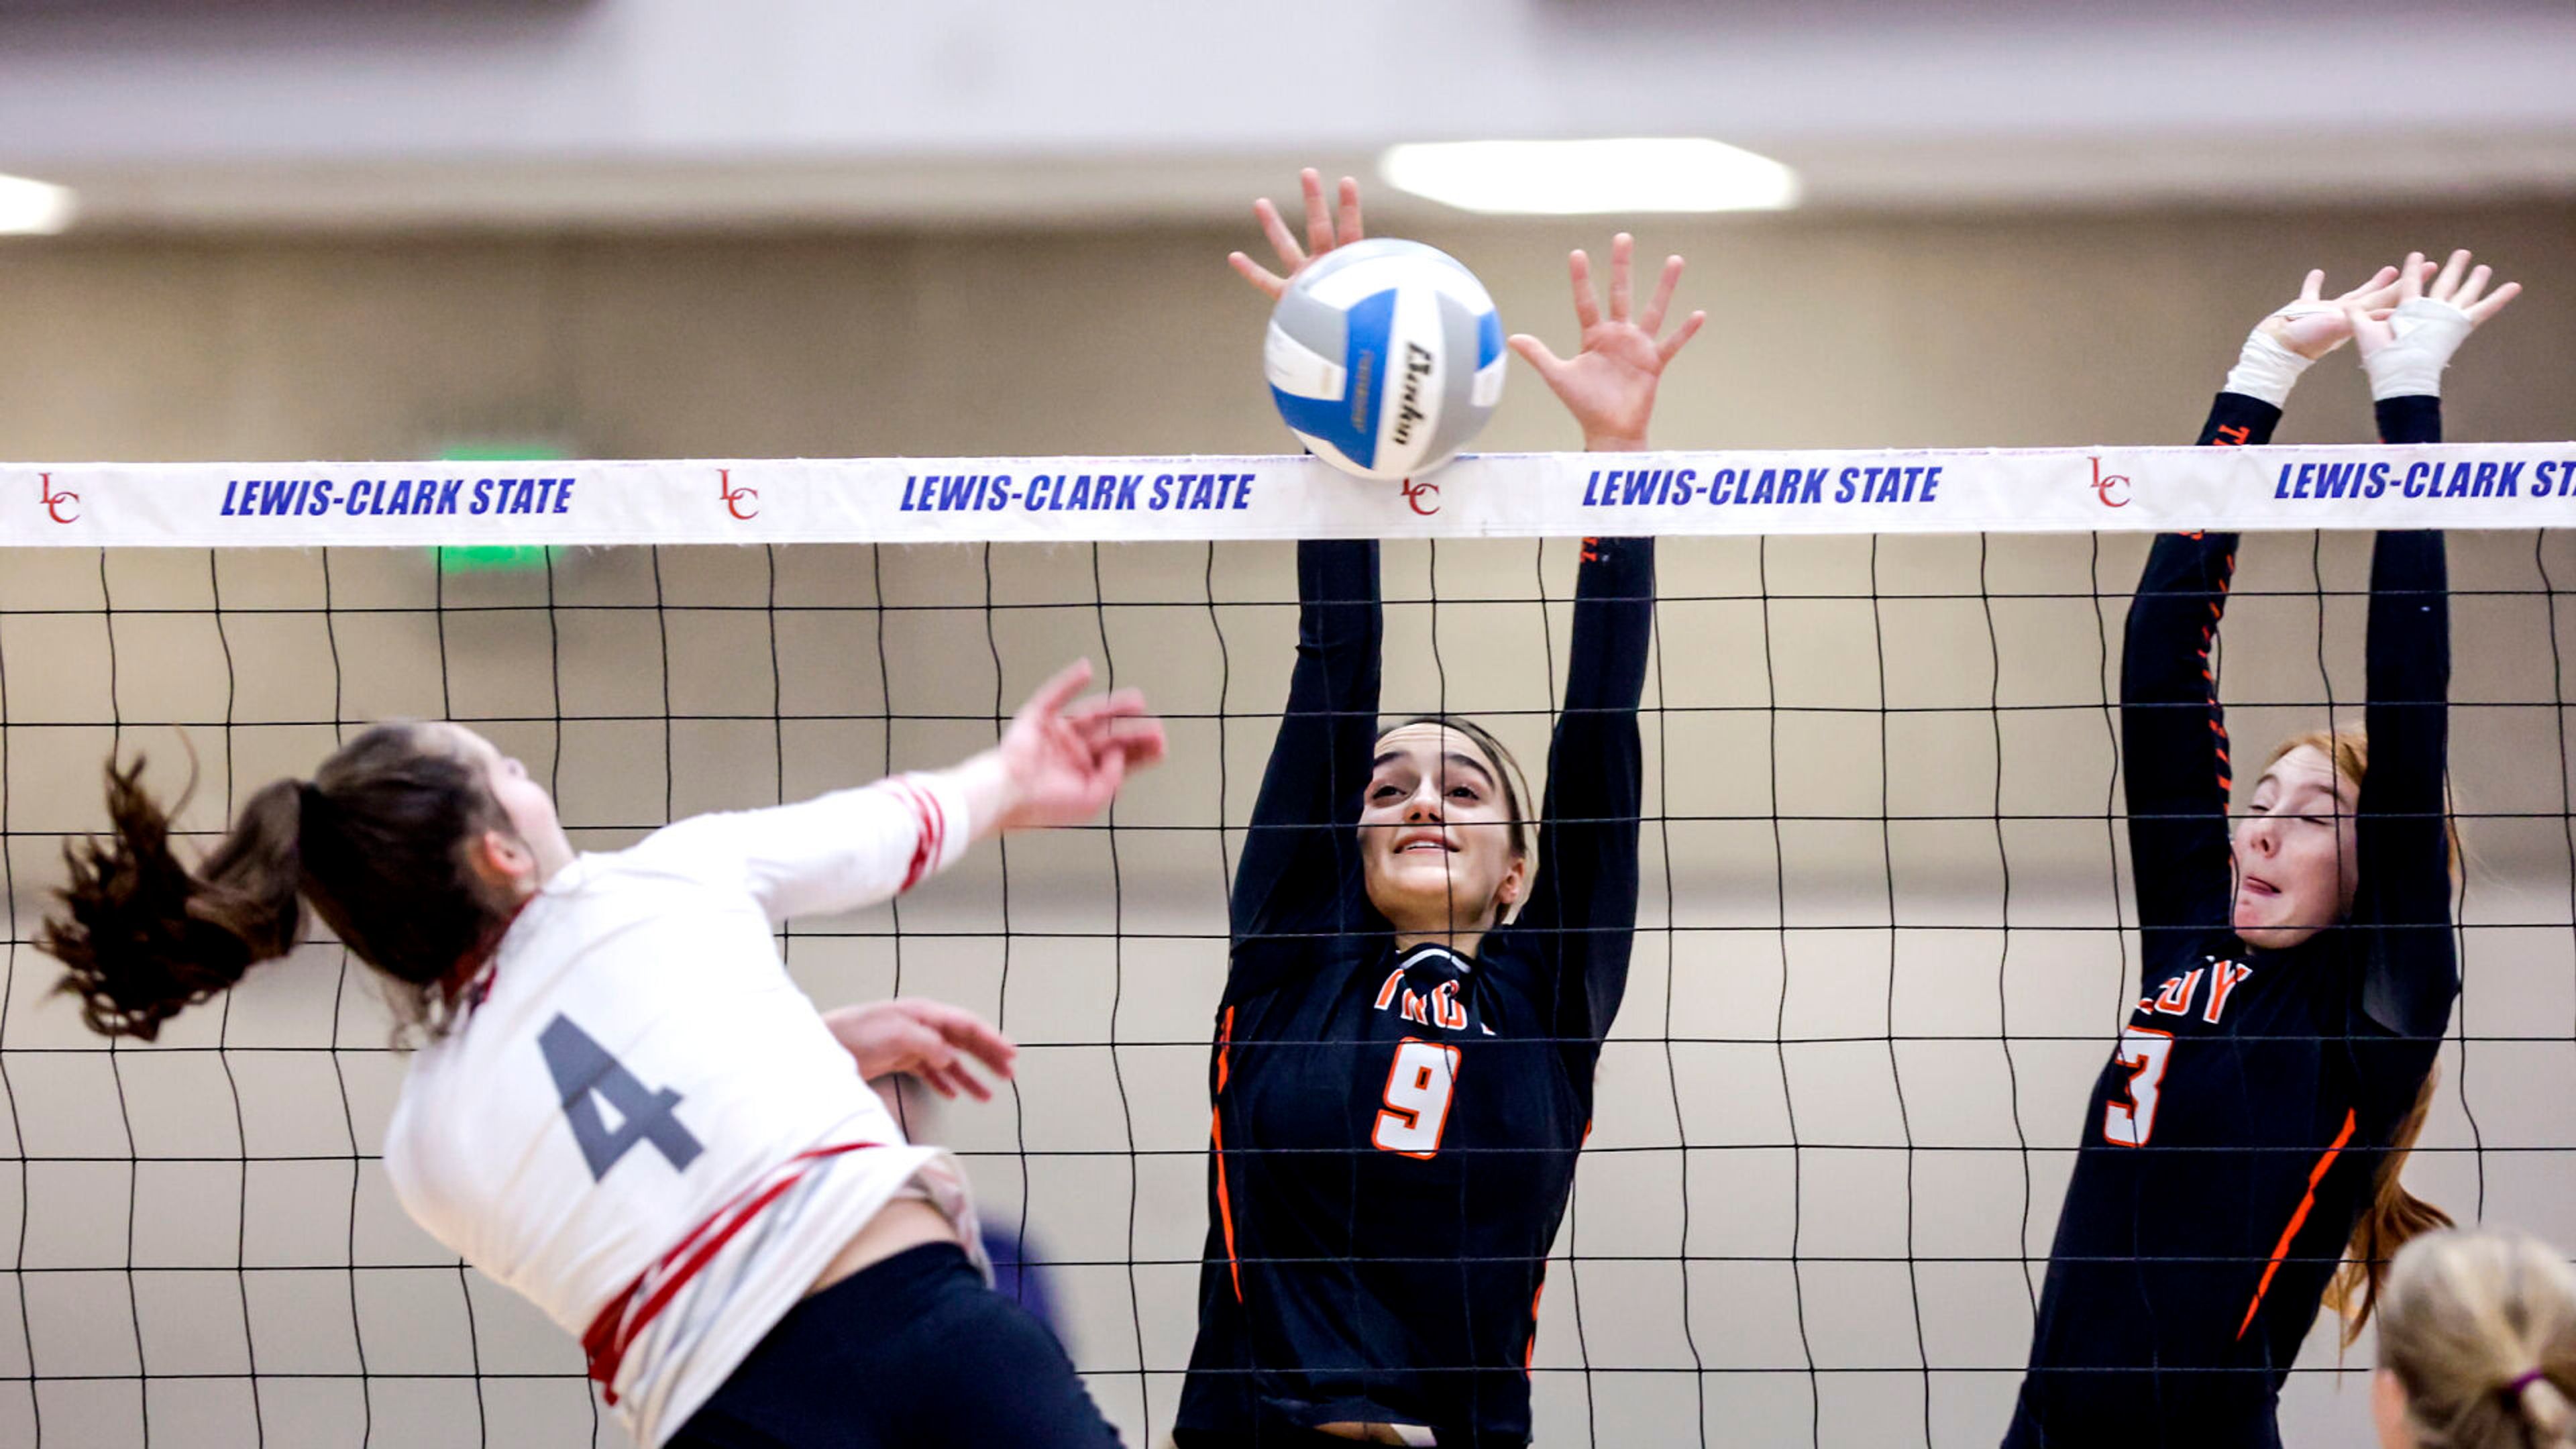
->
[958,660,1165,835]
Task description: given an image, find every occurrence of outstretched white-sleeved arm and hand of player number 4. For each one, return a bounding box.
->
[636,660,1165,920]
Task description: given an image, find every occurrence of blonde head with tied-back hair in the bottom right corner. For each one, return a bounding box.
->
[2370,1232,2576,1449]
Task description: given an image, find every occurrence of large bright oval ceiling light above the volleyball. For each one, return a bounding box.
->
[1378,137,1798,217]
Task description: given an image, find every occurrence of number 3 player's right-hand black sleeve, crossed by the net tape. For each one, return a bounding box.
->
[2352,397,2460,1036]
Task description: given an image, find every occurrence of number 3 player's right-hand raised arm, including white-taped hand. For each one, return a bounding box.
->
[2352,253,2522,1036]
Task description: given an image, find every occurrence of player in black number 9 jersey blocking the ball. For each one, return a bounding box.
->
[1175,170,1703,1449]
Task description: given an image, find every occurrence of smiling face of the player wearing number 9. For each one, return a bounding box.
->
[1360,724,1527,930]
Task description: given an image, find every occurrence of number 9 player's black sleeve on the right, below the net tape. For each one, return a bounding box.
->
[1517,539,1654,1039]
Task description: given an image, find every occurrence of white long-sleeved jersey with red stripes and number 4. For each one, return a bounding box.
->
[384,776,981,1446]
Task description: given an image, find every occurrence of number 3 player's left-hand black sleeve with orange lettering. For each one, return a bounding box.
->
[2120,392,2279,959]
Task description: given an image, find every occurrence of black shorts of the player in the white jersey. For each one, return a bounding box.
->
[669,1227,1118,1449]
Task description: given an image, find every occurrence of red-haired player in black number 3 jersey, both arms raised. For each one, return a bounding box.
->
[2004,253,2517,1449]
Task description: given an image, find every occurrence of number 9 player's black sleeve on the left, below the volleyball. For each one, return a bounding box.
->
[1234,539,1386,944]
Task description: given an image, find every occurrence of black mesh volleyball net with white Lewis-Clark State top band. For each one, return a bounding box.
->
[0,443,2576,1446]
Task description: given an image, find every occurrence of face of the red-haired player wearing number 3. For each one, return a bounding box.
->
[2236,745,2359,951]
